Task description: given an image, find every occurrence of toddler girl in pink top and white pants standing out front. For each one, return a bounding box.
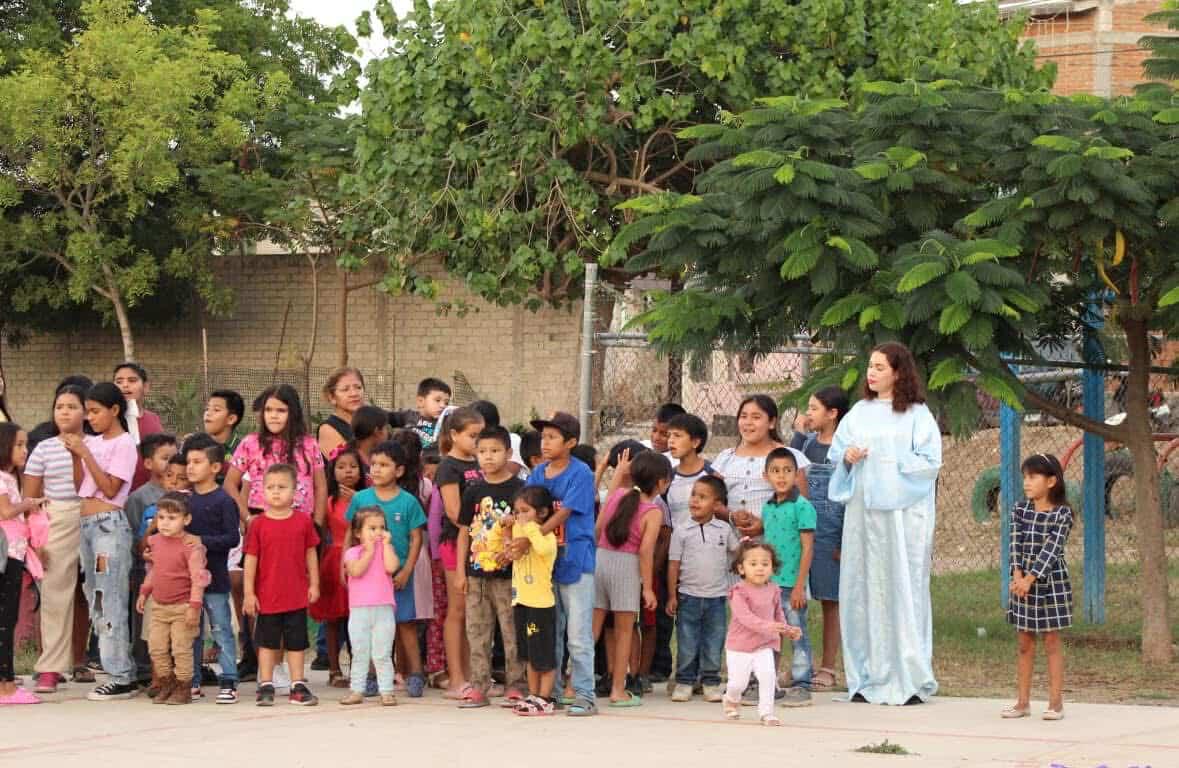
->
[722,538,802,726]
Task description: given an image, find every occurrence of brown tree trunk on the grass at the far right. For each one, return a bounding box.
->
[1119,307,1172,664]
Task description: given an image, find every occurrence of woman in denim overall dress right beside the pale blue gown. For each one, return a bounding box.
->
[793,387,849,690]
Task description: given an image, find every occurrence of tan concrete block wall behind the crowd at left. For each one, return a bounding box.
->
[0,255,580,425]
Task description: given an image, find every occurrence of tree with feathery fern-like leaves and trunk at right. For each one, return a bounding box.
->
[614,80,1179,664]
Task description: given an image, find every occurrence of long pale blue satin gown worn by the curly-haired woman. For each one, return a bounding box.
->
[828,400,942,704]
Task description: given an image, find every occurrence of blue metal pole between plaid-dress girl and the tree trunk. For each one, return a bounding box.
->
[1081,297,1106,624]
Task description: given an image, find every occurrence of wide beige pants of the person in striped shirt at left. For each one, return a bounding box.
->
[34,501,81,675]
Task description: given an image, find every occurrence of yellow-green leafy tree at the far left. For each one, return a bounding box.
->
[0,0,288,359]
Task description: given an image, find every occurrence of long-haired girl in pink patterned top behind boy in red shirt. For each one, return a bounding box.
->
[224,385,328,526]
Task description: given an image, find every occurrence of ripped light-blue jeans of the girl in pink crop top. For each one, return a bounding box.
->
[81,510,134,685]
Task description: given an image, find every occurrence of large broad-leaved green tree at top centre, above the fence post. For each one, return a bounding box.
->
[353,0,1052,307]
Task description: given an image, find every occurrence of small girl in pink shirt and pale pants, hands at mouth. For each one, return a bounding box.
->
[340,506,401,707]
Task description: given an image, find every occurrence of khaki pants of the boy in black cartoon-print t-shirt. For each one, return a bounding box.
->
[459,580,527,692]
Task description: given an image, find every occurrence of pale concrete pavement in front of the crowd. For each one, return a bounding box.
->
[0,672,1179,768]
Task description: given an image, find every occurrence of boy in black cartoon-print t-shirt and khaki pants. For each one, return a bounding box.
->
[455,426,527,709]
